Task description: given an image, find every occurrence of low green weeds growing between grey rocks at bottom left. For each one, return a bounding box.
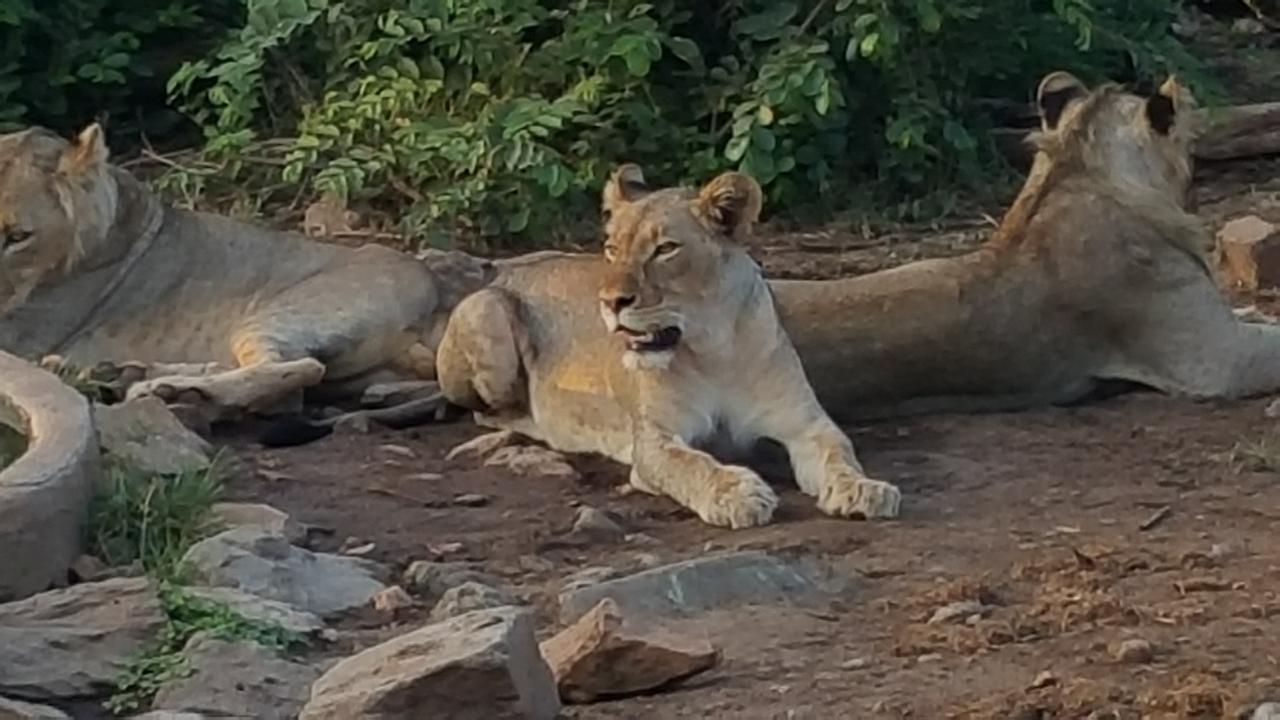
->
[105,583,306,715]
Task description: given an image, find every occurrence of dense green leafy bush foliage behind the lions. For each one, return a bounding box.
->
[0,0,1203,242]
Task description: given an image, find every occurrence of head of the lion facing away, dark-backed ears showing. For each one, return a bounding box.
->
[1032,70,1194,202]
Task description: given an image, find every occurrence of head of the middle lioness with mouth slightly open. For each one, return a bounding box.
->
[599,164,763,366]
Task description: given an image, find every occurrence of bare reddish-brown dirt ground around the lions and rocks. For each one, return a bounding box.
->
[197,16,1280,720]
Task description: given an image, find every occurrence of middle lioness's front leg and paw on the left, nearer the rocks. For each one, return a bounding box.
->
[631,428,778,528]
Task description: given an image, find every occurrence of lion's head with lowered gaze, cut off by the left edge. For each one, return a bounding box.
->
[0,124,118,313]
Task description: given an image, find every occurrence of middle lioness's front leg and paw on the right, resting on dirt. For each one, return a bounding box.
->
[780,418,902,520]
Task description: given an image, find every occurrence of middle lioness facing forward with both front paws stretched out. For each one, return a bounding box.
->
[438,165,900,528]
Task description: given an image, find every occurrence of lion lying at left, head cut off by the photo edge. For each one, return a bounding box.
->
[0,124,494,422]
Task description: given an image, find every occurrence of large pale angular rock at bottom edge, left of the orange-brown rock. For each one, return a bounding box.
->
[300,607,561,720]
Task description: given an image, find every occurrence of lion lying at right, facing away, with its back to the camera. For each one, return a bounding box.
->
[771,72,1280,419]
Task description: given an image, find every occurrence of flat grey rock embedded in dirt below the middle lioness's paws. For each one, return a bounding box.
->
[559,551,841,623]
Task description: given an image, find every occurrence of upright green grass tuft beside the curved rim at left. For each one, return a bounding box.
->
[86,457,223,580]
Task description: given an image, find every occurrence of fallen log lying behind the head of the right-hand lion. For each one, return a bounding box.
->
[991,102,1280,167]
